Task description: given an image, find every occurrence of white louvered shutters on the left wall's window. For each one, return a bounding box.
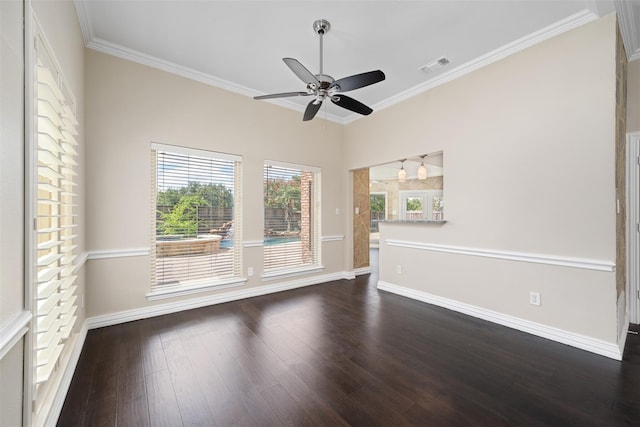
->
[35,58,78,400]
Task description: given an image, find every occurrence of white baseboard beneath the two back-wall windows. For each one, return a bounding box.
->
[87,272,352,329]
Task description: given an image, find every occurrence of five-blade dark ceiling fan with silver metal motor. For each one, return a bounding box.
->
[254,19,385,121]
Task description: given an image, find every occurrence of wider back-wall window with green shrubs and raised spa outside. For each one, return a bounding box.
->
[151,144,242,295]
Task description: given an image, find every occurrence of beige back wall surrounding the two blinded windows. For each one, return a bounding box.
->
[85,51,346,316]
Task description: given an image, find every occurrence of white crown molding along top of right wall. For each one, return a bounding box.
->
[344,9,598,124]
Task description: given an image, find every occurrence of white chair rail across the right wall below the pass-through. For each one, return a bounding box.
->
[384,239,616,272]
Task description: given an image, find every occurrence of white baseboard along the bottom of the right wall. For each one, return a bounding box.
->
[378,281,622,360]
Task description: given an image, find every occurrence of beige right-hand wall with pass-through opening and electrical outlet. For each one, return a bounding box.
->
[344,16,617,343]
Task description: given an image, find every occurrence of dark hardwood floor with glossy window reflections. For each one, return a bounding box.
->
[58,251,640,427]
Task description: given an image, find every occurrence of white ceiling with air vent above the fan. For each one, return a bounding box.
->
[75,0,640,123]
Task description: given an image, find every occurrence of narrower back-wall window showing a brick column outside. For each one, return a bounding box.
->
[264,162,320,277]
